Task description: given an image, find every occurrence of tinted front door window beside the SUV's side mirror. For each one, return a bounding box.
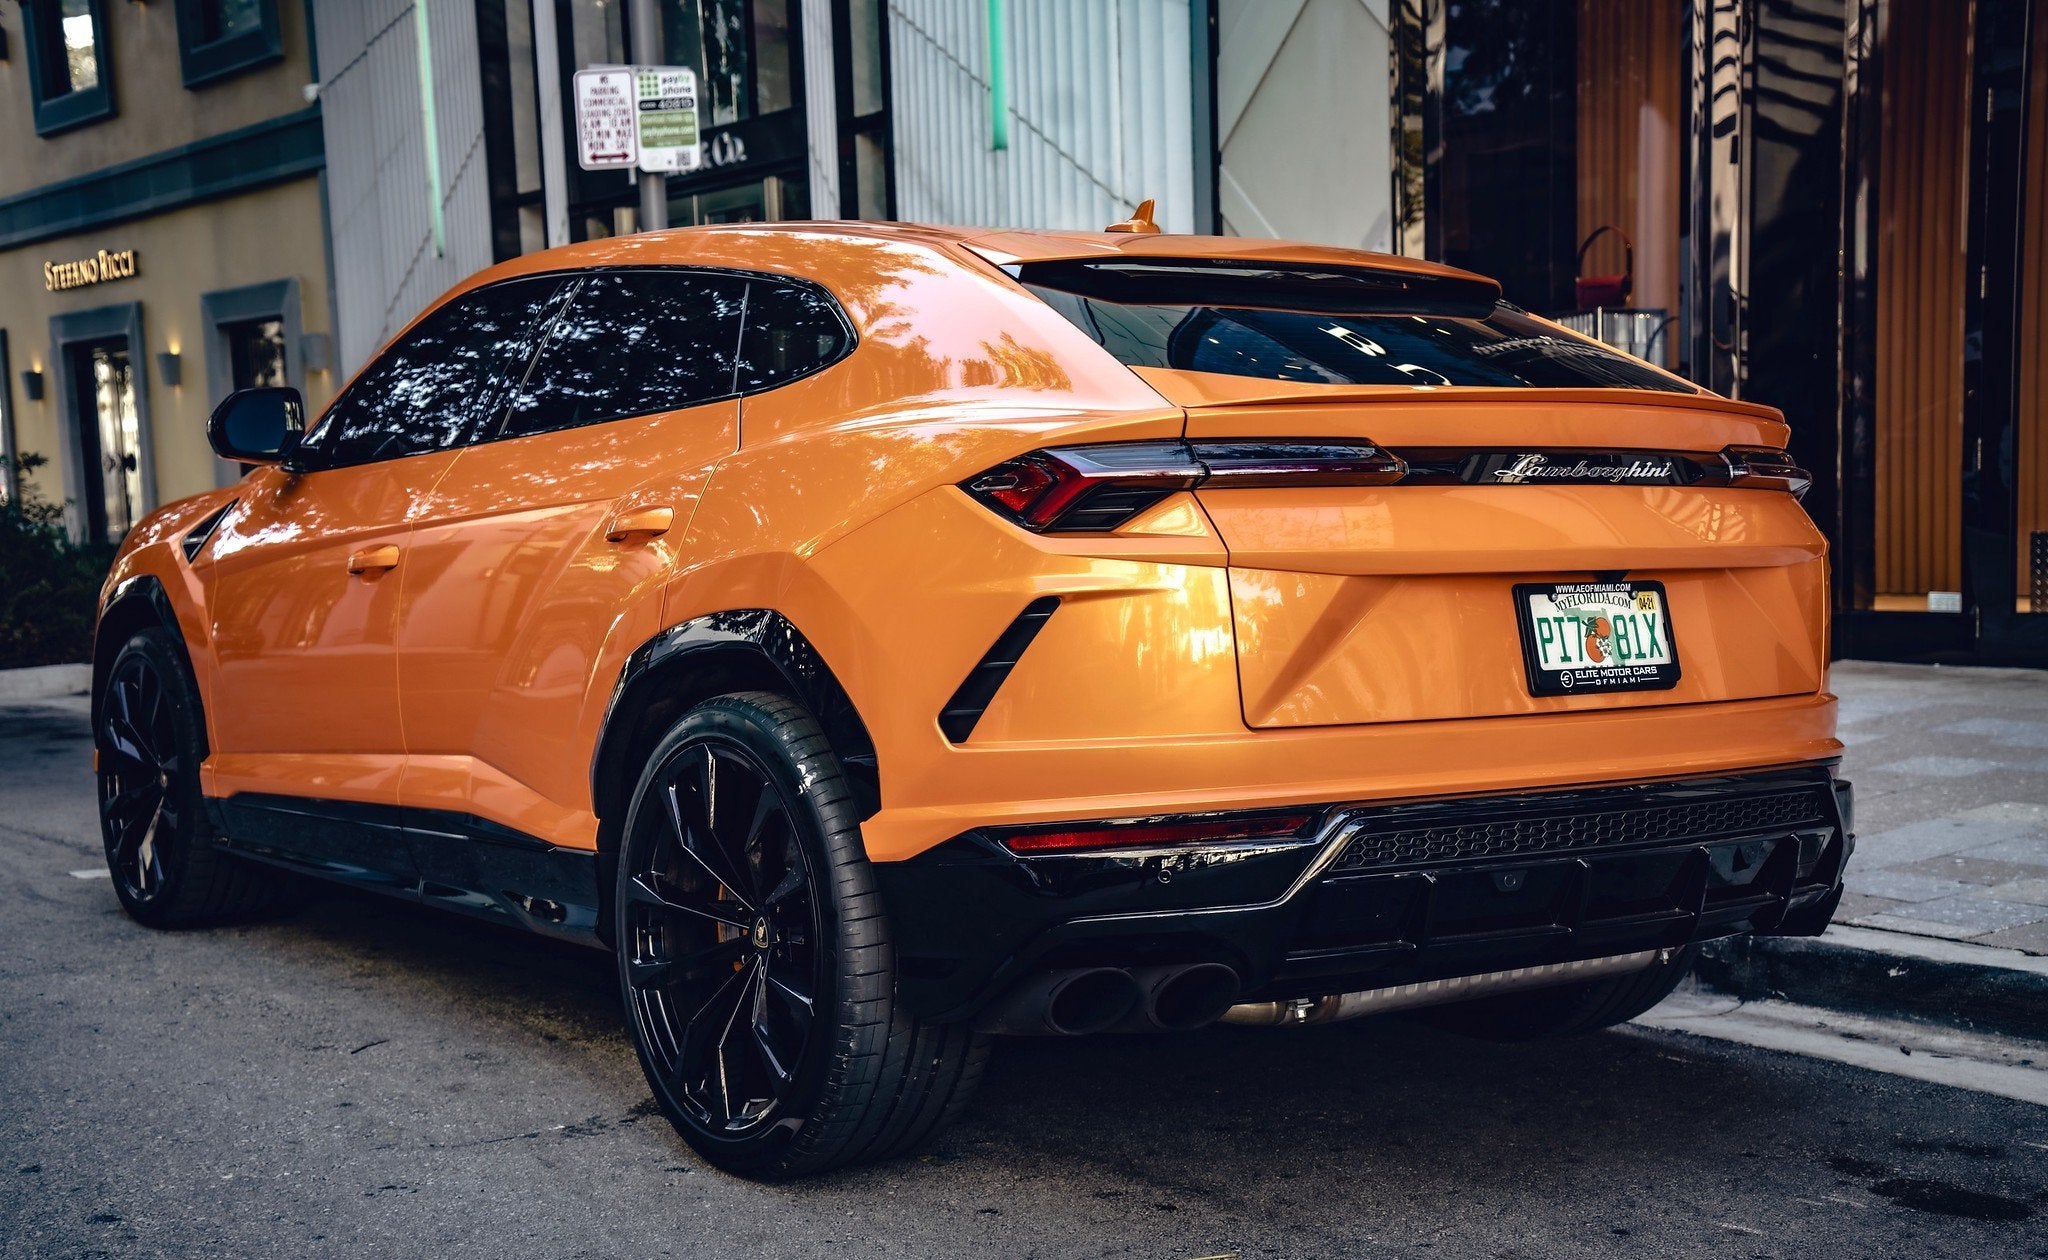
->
[313,277,563,465]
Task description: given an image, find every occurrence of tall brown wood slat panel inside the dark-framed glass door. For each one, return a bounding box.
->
[1872,0,1970,598]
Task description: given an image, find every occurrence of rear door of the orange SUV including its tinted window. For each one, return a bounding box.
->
[399,268,748,852]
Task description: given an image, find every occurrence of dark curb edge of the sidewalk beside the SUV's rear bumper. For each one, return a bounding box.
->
[1696,926,2048,1041]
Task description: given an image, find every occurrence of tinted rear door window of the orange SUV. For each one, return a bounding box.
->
[504,270,748,438]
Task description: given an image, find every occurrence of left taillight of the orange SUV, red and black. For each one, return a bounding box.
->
[961,440,1407,533]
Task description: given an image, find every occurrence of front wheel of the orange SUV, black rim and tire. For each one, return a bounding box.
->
[92,627,291,928]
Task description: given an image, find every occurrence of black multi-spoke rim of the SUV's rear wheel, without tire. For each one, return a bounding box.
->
[621,736,825,1139]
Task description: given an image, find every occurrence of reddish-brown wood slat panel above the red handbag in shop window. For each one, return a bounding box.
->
[1573,0,1683,367]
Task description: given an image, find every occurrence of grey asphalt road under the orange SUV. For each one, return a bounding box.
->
[0,709,2048,1260]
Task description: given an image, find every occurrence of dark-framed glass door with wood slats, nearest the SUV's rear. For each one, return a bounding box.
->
[1831,0,1995,662]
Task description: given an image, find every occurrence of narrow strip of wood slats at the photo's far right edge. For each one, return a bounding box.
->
[2017,0,2048,613]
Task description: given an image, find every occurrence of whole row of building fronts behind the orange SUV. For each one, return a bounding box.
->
[0,0,2048,666]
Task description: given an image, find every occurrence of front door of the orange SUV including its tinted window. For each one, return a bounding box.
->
[199,277,563,869]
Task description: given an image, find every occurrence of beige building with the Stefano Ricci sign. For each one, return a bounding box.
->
[0,0,336,539]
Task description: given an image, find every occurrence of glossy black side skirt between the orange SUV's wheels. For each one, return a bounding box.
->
[207,793,604,949]
